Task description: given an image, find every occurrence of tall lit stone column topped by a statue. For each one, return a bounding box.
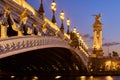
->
[92,14,103,57]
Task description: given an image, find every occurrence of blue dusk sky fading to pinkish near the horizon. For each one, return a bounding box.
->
[27,0,120,55]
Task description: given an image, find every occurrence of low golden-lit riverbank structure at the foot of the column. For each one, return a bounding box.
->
[89,53,120,74]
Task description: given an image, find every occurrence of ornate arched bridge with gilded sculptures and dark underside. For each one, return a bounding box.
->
[0,0,89,76]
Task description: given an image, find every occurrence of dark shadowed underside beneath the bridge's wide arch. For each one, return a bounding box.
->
[0,48,86,76]
